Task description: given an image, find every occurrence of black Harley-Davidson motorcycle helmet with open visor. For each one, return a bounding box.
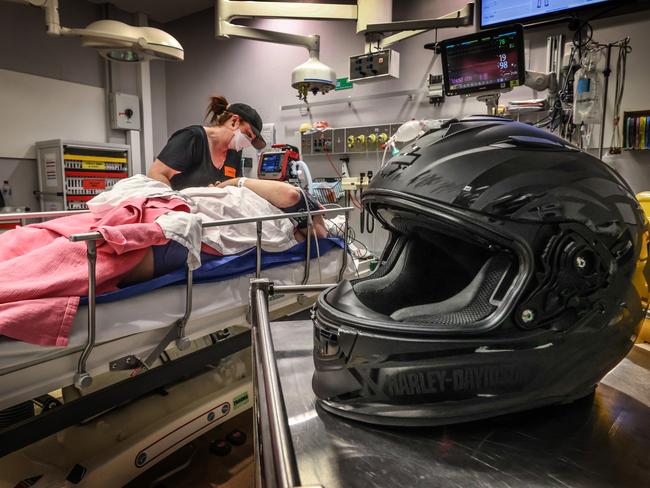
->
[313,116,648,425]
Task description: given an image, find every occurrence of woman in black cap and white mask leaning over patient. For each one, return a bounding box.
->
[148,96,266,190]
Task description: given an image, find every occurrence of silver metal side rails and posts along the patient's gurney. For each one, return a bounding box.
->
[0,207,354,389]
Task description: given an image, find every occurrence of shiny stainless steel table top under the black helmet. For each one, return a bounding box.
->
[271,321,650,488]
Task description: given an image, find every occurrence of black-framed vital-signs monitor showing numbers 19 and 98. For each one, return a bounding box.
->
[440,25,526,96]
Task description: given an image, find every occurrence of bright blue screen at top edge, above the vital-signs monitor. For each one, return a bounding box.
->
[481,0,610,27]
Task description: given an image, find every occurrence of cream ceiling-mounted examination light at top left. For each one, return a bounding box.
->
[8,0,184,62]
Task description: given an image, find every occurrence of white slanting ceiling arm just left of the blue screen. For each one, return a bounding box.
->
[374,3,474,49]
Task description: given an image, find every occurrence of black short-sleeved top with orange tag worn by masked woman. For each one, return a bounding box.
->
[158,125,242,190]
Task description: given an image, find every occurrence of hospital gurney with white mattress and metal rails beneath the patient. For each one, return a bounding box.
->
[0,208,351,466]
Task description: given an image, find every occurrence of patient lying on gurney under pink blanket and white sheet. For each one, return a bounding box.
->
[0,175,327,346]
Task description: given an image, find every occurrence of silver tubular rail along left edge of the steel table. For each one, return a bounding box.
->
[250,278,336,488]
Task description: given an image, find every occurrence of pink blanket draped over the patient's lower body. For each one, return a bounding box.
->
[0,198,189,346]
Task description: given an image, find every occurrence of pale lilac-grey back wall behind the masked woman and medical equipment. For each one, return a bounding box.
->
[163,0,650,255]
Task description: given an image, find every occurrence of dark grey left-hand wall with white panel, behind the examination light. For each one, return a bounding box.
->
[0,0,167,210]
